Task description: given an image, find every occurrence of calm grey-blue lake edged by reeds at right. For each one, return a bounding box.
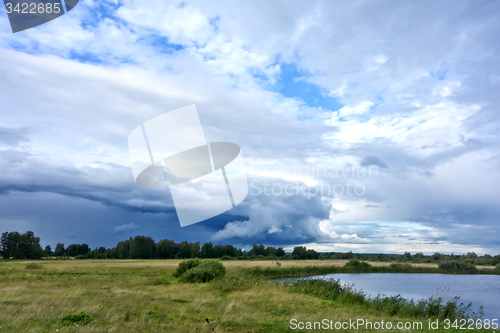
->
[286,273,500,320]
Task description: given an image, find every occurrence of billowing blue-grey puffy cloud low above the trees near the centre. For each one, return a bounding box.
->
[213,176,331,245]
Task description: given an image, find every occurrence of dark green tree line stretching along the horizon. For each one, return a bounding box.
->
[0,231,500,265]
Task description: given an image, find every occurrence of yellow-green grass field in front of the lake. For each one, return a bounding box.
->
[0,260,491,333]
